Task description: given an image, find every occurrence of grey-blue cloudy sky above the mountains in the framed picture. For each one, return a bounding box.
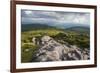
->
[21,10,90,27]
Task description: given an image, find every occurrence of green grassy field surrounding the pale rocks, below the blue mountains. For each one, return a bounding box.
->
[21,28,90,63]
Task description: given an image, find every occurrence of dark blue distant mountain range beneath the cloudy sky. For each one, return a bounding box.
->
[21,23,90,32]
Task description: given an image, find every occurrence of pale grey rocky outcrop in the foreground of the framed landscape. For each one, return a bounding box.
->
[31,36,90,62]
